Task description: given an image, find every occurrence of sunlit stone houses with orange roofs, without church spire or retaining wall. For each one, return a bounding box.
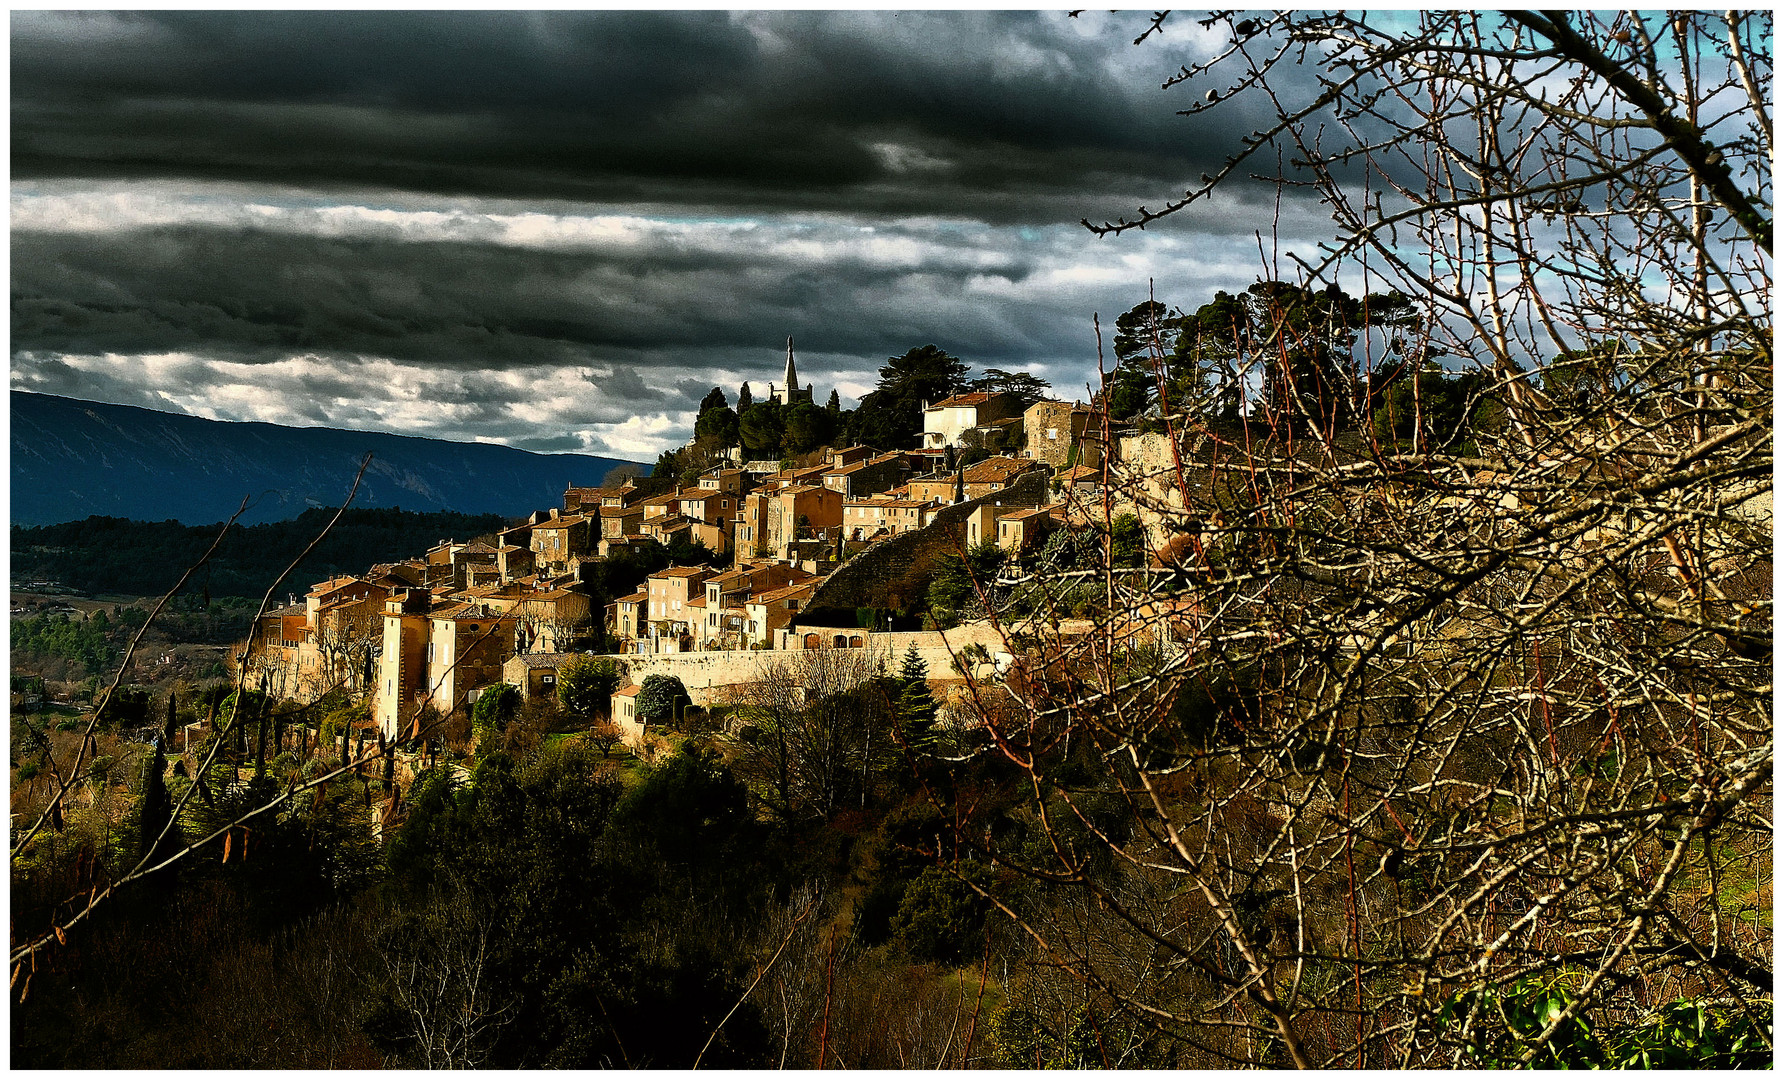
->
[237,392,1102,738]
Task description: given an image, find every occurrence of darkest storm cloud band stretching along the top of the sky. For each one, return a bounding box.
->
[12,11,1276,221]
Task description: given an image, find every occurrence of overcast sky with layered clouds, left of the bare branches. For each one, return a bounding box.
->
[11,11,1330,460]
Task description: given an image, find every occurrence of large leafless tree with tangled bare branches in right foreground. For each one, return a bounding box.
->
[961,11,1772,1068]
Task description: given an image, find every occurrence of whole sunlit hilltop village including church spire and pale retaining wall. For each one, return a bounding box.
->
[237,348,1155,745]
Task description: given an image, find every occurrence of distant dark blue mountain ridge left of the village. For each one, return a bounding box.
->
[12,390,649,526]
